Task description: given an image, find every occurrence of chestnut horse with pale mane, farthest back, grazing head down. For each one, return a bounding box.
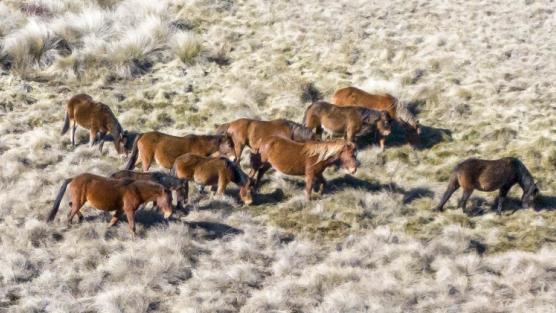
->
[331,87,421,143]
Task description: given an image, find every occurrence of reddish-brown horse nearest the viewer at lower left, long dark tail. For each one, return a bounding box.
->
[47,173,172,237]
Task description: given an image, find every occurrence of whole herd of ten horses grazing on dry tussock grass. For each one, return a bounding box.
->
[48,87,539,236]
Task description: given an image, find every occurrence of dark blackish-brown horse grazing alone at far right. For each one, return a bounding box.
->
[434,158,539,214]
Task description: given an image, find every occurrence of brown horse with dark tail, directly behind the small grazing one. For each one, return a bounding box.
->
[125,131,234,172]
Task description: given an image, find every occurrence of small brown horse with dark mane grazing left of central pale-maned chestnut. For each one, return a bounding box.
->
[172,153,253,205]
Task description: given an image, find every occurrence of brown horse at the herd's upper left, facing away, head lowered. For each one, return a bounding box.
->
[62,94,124,153]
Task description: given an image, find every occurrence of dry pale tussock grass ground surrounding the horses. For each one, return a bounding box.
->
[0,0,556,312]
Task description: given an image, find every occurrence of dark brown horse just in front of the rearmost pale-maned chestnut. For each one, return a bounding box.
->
[303,101,392,150]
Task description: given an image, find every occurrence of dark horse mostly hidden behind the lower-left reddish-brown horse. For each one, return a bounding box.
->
[110,170,187,213]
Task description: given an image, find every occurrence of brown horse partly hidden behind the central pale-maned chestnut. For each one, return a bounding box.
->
[216,118,316,162]
